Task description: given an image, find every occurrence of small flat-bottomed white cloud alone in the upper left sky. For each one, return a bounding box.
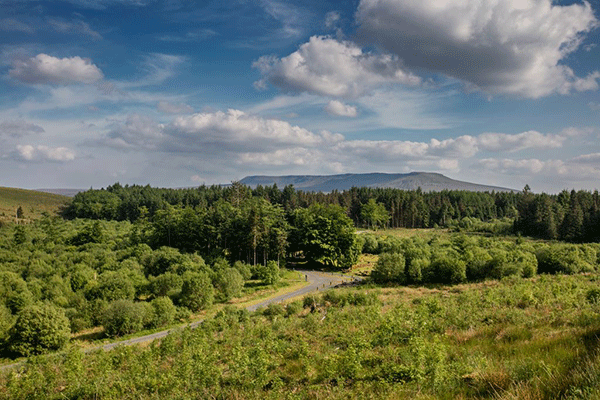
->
[8,53,103,84]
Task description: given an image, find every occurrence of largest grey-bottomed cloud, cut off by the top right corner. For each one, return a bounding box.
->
[356,0,600,98]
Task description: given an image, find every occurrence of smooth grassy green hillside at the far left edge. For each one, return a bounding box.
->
[0,187,70,222]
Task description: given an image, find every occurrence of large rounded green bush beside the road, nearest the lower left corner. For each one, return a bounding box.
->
[10,304,71,356]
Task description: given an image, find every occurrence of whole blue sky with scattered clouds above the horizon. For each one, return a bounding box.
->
[0,0,600,193]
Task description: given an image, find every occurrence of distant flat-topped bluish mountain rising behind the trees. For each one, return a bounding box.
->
[240,172,516,192]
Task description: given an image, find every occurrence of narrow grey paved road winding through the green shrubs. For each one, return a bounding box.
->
[0,270,362,371]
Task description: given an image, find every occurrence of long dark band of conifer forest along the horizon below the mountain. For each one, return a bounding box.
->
[65,182,600,242]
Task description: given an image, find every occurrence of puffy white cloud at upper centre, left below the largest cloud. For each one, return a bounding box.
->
[253,36,420,97]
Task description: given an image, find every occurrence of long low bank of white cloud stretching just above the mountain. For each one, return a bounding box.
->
[100,109,580,172]
